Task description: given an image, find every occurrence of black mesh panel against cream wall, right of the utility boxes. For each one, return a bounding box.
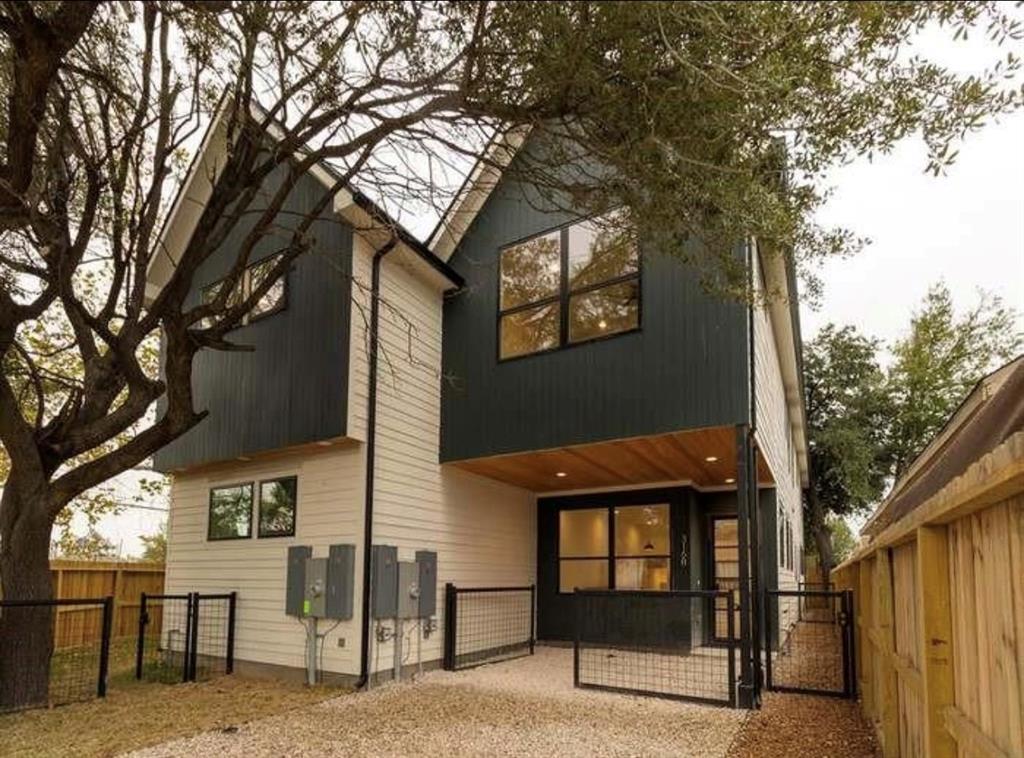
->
[443,584,537,671]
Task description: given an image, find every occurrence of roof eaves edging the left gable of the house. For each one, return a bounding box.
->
[146,97,464,297]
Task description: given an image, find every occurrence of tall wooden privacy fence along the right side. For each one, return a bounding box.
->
[833,432,1024,758]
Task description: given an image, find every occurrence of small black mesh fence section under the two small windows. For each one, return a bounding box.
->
[135,592,238,683]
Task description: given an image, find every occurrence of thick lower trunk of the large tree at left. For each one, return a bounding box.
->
[0,475,54,712]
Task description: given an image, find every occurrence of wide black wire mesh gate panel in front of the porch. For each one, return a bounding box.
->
[572,590,737,706]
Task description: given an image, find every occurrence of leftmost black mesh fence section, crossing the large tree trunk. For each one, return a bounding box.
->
[0,597,114,711]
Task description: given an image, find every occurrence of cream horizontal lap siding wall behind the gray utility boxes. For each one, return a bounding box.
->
[166,229,537,675]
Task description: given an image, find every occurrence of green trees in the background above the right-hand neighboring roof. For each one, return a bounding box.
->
[804,283,1024,562]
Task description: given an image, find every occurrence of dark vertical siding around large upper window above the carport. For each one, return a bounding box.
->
[441,145,749,461]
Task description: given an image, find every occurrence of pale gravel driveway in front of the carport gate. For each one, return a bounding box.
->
[132,646,745,758]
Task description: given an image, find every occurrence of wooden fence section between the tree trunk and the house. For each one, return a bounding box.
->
[50,560,164,648]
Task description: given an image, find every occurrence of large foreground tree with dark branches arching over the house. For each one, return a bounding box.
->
[0,0,1020,706]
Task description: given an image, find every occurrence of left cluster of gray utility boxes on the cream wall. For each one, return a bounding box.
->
[285,545,355,619]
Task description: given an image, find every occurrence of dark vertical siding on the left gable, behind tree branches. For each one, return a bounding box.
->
[155,169,352,471]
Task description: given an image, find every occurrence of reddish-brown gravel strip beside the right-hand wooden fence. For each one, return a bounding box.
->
[729,692,882,758]
